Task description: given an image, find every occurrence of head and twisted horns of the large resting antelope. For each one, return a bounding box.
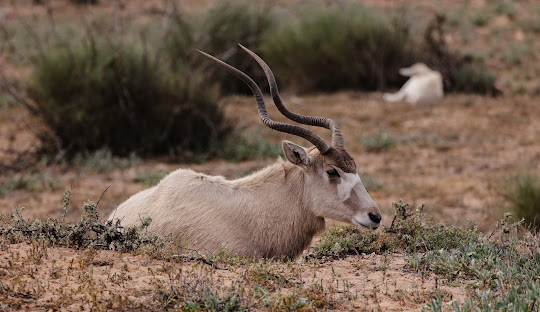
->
[199,45,382,229]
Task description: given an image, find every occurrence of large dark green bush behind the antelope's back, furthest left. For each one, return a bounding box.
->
[27,38,225,155]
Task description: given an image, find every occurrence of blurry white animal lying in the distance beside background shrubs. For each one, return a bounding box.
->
[384,63,444,103]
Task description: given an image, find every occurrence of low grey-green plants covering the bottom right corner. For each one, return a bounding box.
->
[419,214,540,311]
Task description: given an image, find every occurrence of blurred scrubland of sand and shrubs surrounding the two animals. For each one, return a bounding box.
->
[0,0,540,311]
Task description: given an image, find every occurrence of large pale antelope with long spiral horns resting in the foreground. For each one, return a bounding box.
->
[109,45,382,259]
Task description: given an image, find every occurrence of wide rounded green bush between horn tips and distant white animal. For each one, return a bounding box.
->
[262,4,414,91]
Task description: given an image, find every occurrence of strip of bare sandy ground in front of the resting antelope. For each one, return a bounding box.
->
[0,244,466,311]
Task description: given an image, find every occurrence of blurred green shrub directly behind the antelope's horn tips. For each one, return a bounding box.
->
[167,1,272,94]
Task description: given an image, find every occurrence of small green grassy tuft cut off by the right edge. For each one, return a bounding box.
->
[502,172,540,228]
